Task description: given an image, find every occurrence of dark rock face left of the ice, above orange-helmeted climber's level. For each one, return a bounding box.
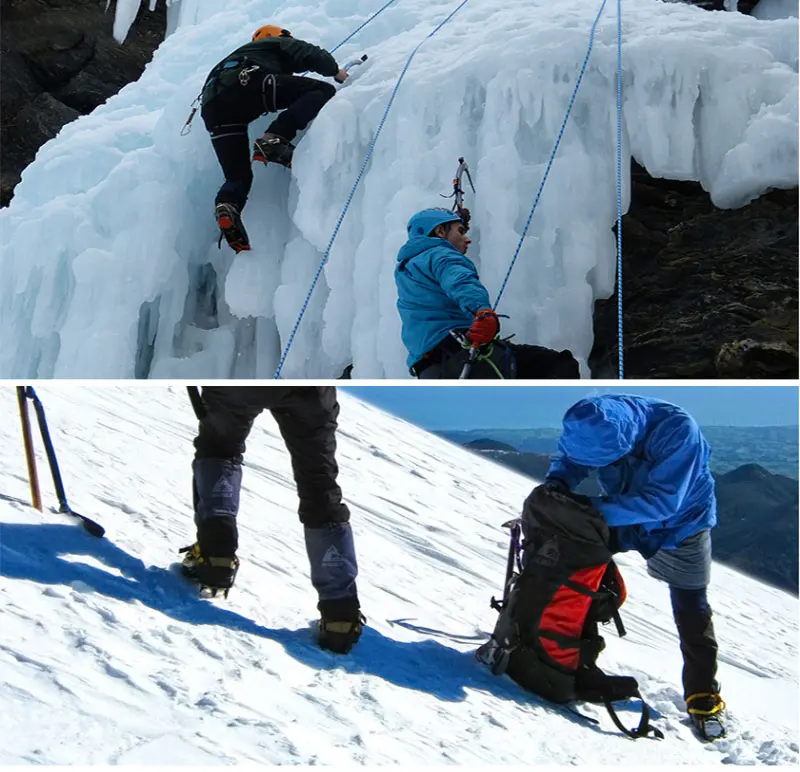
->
[0,0,166,206]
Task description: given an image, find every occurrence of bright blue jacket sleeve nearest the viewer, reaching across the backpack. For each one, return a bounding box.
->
[593,416,705,526]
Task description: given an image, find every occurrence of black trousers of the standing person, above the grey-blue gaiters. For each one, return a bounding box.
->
[194,386,350,528]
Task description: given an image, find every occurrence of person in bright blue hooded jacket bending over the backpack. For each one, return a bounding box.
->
[545,394,725,739]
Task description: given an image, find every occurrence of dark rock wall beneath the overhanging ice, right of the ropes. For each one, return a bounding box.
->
[589,165,798,379]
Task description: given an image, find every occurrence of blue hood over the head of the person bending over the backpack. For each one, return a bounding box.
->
[558,395,647,467]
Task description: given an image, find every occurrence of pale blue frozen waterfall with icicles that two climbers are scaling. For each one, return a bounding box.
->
[0,0,798,378]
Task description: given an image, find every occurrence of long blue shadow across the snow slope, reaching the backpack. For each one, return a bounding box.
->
[0,516,614,734]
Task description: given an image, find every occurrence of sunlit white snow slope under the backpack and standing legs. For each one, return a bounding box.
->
[0,383,798,769]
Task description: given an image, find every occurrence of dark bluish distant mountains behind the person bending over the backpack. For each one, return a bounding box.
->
[450,438,798,595]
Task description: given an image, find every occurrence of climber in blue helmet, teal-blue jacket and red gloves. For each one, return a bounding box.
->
[394,208,580,379]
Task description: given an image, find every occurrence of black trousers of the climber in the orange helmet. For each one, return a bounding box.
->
[201,72,336,211]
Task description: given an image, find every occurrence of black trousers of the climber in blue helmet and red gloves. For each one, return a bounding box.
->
[415,338,581,380]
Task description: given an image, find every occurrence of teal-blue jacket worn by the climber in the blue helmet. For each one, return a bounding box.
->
[394,236,491,367]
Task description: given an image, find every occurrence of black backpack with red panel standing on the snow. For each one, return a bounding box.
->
[476,485,663,739]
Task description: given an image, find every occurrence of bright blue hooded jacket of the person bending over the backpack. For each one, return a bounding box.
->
[547,394,717,557]
